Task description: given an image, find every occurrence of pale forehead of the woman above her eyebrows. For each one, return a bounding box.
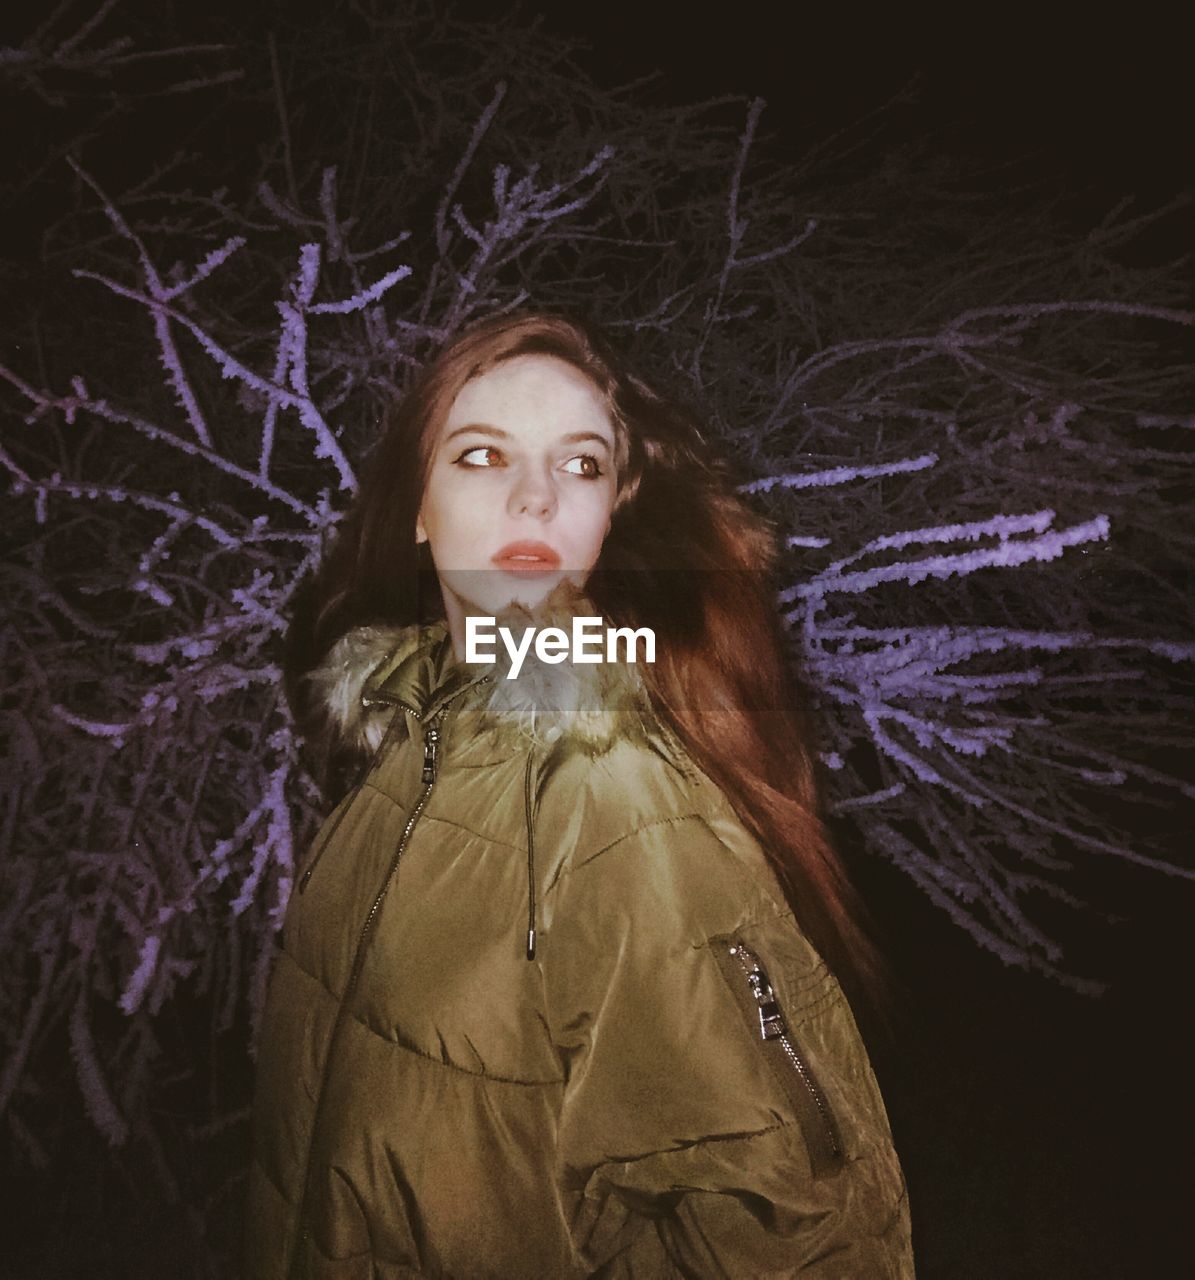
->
[443,355,614,442]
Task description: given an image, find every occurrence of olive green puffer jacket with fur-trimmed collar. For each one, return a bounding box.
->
[246,616,914,1280]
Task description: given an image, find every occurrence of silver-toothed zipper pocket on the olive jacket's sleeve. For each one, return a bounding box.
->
[722,938,846,1175]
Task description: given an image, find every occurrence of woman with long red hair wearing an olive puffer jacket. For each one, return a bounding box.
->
[247,315,912,1280]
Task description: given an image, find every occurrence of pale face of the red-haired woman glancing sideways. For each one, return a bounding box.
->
[416,355,617,632]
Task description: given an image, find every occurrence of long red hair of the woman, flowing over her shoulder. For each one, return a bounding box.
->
[285,312,884,1005]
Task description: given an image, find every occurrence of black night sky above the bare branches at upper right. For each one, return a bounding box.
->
[529,0,1195,211]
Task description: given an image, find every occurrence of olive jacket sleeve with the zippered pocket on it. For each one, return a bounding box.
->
[544,815,914,1277]
